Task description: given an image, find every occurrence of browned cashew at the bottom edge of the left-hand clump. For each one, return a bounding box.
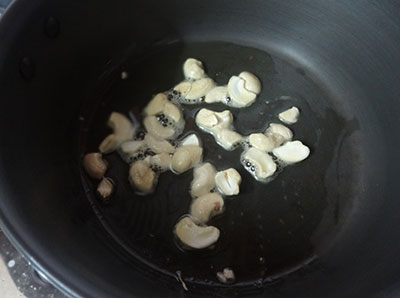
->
[129,160,157,194]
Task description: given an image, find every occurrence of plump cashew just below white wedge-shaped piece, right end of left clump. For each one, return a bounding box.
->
[171,145,203,174]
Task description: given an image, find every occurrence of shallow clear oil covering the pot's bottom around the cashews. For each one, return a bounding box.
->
[82,43,358,287]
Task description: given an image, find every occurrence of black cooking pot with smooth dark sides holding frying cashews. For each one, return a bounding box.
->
[0,0,400,297]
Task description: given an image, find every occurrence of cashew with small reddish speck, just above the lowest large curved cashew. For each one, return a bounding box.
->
[190,193,224,224]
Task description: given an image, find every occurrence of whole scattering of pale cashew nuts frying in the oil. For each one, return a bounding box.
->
[83,58,310,256]
